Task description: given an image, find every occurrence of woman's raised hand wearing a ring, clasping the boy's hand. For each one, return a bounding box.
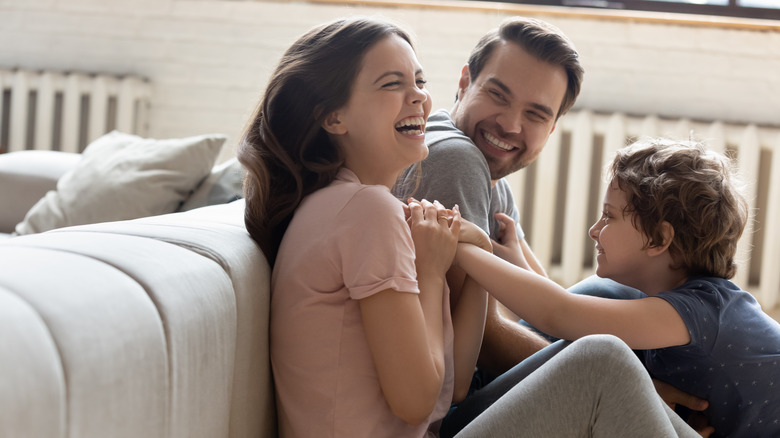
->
[408,198,461,275]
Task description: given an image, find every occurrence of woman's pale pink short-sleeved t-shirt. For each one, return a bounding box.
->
[271,169,453,438]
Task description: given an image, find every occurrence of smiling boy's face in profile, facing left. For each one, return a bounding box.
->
[589,180,649,290]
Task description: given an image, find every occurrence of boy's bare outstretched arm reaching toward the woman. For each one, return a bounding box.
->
[455,243,690,349]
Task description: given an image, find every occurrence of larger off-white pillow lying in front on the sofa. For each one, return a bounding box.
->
[16,131,226,234]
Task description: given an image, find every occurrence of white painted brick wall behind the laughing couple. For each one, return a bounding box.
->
[0,0,780,161]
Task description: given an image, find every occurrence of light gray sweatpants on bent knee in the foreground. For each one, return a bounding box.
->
[456,335,699,438]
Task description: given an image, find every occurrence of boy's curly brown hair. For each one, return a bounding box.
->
[607,138,748,279]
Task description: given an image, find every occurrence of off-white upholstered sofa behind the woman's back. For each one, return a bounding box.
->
[0,150,275,438]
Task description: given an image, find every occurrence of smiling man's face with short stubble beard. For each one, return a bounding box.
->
[452,41,567,181]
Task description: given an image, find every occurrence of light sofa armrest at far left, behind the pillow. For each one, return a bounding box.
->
[0,151,81,233]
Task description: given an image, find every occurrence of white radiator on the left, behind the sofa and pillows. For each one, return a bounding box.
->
[0,68,150,152]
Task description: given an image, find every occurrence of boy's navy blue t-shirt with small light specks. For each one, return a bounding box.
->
[644,277,780,438]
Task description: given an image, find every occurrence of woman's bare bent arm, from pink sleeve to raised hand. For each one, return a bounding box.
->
[360,201,460,425]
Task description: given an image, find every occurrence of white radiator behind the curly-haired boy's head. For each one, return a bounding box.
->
[509,110,780,310]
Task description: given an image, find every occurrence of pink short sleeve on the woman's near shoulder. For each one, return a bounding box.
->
[338,186,419,299]
